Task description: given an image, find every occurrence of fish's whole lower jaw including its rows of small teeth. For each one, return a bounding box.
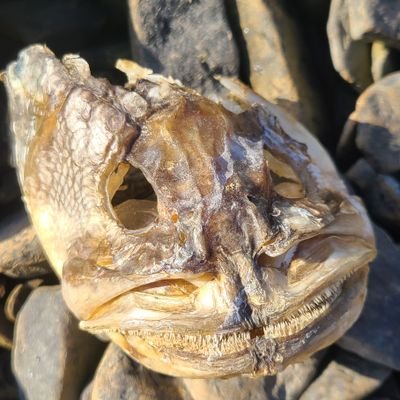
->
[80,266,369,378]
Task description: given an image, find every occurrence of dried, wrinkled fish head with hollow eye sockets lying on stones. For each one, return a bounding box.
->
[3,45,375,378]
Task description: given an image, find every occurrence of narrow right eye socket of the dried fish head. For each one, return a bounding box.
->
[264,150,305,199]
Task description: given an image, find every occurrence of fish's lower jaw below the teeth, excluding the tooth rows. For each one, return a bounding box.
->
[109,267,368,378]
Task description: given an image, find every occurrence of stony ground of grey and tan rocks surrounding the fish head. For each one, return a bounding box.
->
[0,0,400,400]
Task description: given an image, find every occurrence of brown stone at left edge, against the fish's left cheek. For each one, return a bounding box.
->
[0,210,51,278]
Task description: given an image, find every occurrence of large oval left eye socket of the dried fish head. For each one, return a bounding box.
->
[108,163,158,230]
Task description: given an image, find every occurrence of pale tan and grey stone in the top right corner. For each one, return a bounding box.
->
[328,0,400,90]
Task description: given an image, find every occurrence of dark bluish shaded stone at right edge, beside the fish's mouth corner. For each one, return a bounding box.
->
[338,226,400,371]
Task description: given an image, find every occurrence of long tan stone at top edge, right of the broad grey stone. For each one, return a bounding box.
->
[236,0,323,136]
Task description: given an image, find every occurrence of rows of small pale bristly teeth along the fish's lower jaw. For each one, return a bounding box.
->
[86,272,353,354]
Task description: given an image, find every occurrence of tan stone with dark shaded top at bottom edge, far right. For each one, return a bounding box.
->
[300,352,391,400]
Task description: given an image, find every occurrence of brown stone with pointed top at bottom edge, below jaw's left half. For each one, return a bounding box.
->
[88,344,181,400]
